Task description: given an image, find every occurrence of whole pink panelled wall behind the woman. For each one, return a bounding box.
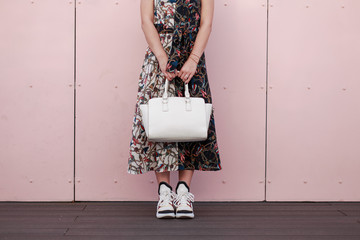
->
[0,0,360,201]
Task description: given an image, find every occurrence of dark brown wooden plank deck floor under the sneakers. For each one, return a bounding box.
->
[0,201,360,240]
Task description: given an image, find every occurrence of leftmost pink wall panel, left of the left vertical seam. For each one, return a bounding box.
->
[0,0,74,201]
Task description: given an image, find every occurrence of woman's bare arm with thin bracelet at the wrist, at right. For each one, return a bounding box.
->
[177,0,214,83]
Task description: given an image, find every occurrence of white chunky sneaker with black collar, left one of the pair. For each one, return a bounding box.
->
[156,182,176,218]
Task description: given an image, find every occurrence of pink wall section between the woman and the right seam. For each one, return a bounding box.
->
[202,0,266,201]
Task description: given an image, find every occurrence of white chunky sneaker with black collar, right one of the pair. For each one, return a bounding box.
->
[174,181,194,218]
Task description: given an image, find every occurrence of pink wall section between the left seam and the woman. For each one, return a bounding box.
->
[75,0,153,201]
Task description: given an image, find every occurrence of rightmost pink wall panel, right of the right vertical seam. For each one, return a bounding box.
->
[266,0,360,201]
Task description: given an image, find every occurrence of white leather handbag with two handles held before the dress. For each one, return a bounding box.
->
[140,79,213,142]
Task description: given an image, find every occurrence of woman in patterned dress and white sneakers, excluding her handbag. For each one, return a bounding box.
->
[127,0,221,218]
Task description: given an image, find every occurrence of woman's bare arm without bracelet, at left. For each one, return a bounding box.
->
[140,0,175,80]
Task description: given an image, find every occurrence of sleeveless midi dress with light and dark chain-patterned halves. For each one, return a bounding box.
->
[127,0,222,174]
